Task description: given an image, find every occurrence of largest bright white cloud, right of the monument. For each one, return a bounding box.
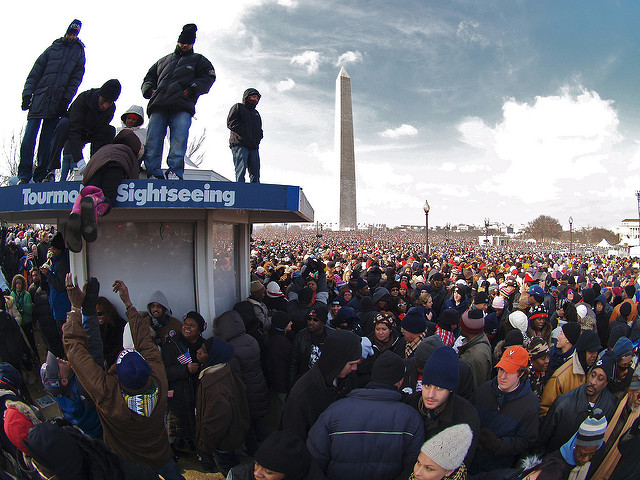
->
[458,87,622,203]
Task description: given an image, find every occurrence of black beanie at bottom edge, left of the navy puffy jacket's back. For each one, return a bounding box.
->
[253,431,311,479]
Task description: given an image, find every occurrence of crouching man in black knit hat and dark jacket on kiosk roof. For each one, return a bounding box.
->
[44,78,122,182]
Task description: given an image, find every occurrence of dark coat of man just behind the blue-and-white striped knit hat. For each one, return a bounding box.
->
[537,385,616,453]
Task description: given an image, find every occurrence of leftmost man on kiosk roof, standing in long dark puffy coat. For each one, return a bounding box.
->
[18,20,85,183]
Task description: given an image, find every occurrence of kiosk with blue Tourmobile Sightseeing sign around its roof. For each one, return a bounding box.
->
[0,170,314,326]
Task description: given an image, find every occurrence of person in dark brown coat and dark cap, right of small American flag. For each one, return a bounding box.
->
[196,337,251,476]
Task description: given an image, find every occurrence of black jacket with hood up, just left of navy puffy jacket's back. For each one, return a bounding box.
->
[282,330,362,440]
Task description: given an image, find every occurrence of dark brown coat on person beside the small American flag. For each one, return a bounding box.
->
[196,363,251,453]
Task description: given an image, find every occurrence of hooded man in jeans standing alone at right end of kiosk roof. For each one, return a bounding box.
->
[227,88,263,183]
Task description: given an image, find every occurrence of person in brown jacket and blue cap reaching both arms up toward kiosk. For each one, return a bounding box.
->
[63,274,184,480]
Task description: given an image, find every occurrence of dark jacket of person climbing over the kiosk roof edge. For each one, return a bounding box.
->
[82,129,142,185]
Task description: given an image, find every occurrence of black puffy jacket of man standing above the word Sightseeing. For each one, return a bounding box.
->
[142,47,216,116]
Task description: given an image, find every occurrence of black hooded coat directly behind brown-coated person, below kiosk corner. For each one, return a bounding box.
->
[214,310,270,419]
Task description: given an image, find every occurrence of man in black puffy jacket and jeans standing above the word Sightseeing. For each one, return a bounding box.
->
[142,23,216,180]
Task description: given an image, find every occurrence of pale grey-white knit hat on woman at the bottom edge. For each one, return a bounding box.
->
[420,423,473,470]
